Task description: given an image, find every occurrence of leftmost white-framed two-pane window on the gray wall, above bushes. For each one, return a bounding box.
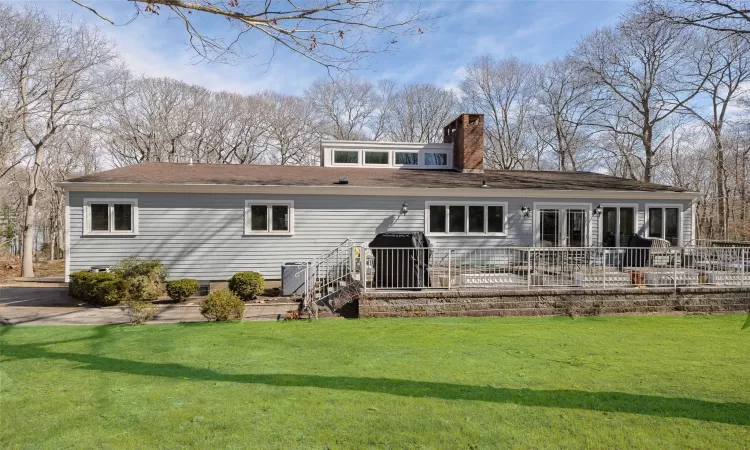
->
[83,199,138,235]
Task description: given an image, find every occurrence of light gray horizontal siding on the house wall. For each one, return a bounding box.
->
[70,192,692,280]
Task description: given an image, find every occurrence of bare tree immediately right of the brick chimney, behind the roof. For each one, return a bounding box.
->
[461,56,536,170]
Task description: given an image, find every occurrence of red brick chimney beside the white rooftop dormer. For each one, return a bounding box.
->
[443,114,484,173]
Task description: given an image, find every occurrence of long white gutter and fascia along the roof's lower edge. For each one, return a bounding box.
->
[57,182,702,200]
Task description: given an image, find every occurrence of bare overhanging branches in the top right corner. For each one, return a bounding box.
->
[639,0,750,36]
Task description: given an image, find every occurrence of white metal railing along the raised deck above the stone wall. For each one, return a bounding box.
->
[360,247,750,290]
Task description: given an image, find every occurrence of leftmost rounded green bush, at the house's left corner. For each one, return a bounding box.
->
[70,272,130,306]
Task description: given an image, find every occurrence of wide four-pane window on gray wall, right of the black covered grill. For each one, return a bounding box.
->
[427,203,507,235]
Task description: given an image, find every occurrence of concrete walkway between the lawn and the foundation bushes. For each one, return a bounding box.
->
[0,283,298,325]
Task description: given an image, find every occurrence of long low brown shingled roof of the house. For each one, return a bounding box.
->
[68,162,685,192]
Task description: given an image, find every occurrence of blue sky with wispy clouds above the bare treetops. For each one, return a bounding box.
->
[10,0,630,94]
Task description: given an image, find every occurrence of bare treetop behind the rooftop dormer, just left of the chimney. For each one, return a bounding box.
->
[380,83,458,142]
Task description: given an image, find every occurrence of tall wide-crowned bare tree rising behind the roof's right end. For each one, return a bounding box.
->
[574,16,705,181]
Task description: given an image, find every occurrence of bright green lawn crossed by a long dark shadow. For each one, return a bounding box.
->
[0,315,750,448]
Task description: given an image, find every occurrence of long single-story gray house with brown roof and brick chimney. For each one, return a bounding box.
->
[61,114,697,281]
